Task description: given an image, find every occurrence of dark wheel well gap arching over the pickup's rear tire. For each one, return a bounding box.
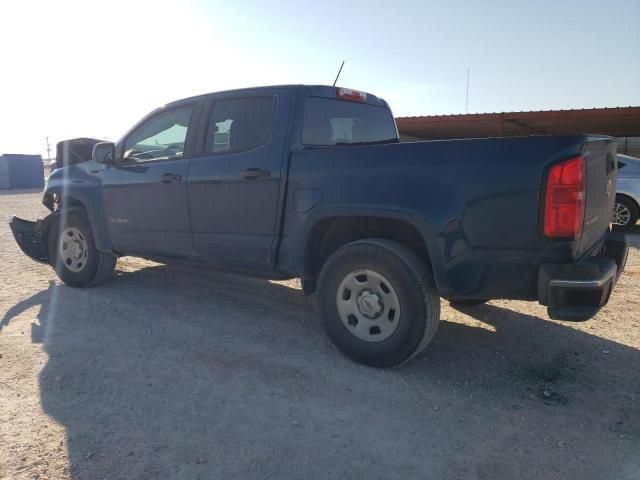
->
[304,217,431,294]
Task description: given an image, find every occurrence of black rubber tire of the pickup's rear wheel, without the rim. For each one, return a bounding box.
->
[318,238,440,367]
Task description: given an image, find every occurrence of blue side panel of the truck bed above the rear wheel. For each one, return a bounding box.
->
[280,135,600,298]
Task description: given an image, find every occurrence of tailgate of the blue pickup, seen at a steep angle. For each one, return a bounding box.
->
[578,137,618,256]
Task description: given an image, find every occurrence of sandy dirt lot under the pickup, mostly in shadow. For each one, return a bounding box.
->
[0,192,640,480]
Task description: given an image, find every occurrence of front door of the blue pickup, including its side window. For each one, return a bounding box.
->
[103,105,194,255]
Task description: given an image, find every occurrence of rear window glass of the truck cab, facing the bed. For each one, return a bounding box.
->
[302,97,398,145]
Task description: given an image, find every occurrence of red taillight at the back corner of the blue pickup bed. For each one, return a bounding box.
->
[544,157,585,238]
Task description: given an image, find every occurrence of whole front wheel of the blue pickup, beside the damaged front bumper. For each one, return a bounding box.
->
[49,210,117,287]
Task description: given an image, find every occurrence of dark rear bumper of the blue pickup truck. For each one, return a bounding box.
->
[538,232,629,322]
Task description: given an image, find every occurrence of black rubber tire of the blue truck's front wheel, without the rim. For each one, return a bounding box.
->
[48,210,117,288]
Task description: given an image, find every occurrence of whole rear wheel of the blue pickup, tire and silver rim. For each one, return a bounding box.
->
[318,239,440,367]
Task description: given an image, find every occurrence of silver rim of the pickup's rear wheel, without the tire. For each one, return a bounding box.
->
[336,269,400,342]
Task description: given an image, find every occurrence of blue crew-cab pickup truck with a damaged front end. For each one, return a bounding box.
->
[11,85,628,367]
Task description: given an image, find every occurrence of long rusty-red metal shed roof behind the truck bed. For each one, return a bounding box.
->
[396,107,640,157]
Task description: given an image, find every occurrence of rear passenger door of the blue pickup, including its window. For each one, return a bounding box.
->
[187,89,291,266]
